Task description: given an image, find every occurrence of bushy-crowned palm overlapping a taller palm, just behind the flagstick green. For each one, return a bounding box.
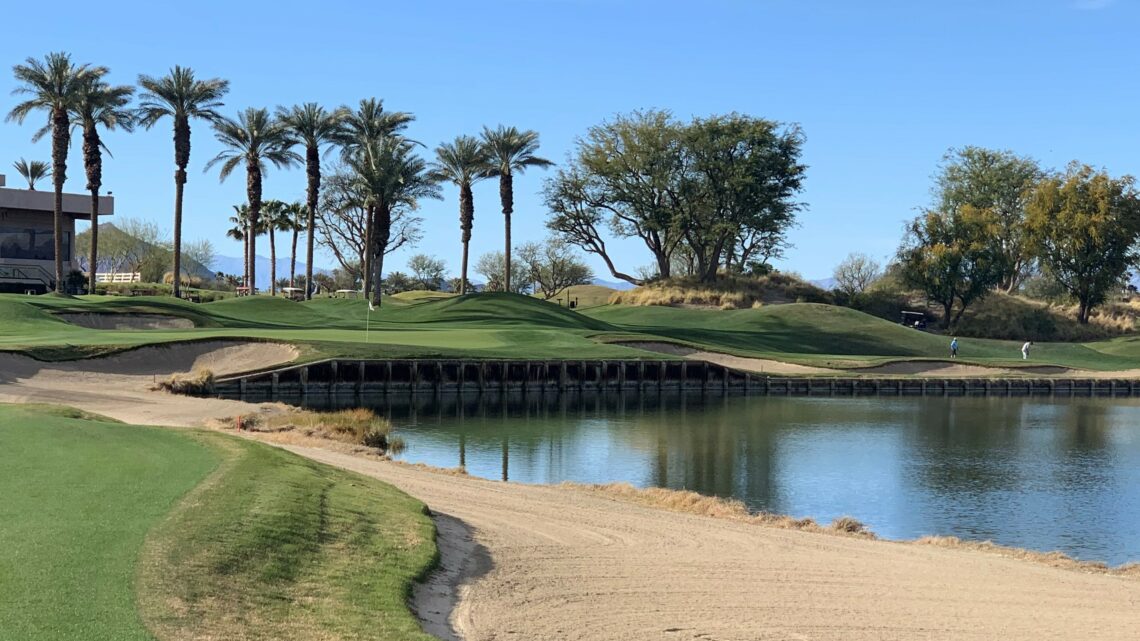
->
[345,136,440,306]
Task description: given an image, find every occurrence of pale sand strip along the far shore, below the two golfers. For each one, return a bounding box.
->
[618,342,1140,379]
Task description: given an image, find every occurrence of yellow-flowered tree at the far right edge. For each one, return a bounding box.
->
[1026,163,1140,324]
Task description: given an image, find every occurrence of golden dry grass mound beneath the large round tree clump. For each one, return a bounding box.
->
[610,274,832,309]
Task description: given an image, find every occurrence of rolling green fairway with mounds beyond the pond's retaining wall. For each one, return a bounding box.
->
[0,293,1140,371]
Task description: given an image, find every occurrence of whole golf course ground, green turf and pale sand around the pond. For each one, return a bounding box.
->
[0,294,1140,640]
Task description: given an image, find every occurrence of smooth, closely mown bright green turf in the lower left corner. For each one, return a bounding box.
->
[0,405,219,641]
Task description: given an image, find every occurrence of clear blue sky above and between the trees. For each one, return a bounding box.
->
[0,0,1140,278]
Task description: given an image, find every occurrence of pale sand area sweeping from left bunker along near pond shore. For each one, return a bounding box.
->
[0,343,1140,641]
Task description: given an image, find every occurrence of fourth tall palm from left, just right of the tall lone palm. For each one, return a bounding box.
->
[206,107,301,291]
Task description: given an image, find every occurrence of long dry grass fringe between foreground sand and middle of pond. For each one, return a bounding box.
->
[562,482,874,538]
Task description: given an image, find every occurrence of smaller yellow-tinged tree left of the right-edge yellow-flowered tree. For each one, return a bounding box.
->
[898,205,1005,328]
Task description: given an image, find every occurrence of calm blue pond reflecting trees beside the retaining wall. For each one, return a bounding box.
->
[323,393,1140,565]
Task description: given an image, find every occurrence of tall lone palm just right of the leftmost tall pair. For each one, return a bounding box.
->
[138,65,229,297]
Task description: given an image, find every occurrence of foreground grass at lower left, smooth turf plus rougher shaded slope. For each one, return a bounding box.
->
[0,405,437,641]
